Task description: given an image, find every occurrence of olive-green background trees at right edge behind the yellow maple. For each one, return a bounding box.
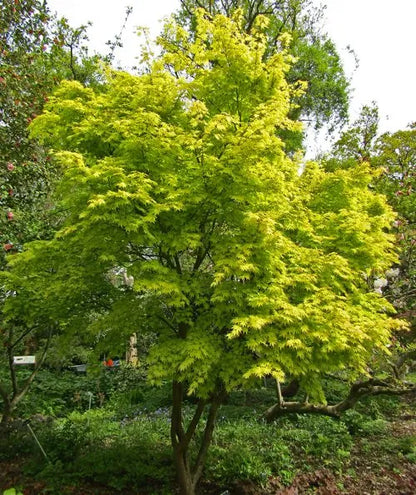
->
[324,103,416,384]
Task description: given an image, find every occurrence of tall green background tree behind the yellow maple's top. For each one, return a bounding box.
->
[177,0,349,140]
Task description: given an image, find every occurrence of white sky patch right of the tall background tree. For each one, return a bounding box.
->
[325,0,416,131]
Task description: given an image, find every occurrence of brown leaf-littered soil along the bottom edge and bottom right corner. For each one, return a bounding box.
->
[0,414,416,495]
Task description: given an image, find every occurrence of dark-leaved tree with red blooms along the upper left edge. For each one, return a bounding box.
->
[0,0,54,258]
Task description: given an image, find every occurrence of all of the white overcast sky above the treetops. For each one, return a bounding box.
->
[48,0,416,151]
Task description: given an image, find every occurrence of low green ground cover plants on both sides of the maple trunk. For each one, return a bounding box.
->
[0,370,416,495]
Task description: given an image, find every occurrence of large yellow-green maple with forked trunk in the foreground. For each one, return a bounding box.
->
[3,11,399,494]
